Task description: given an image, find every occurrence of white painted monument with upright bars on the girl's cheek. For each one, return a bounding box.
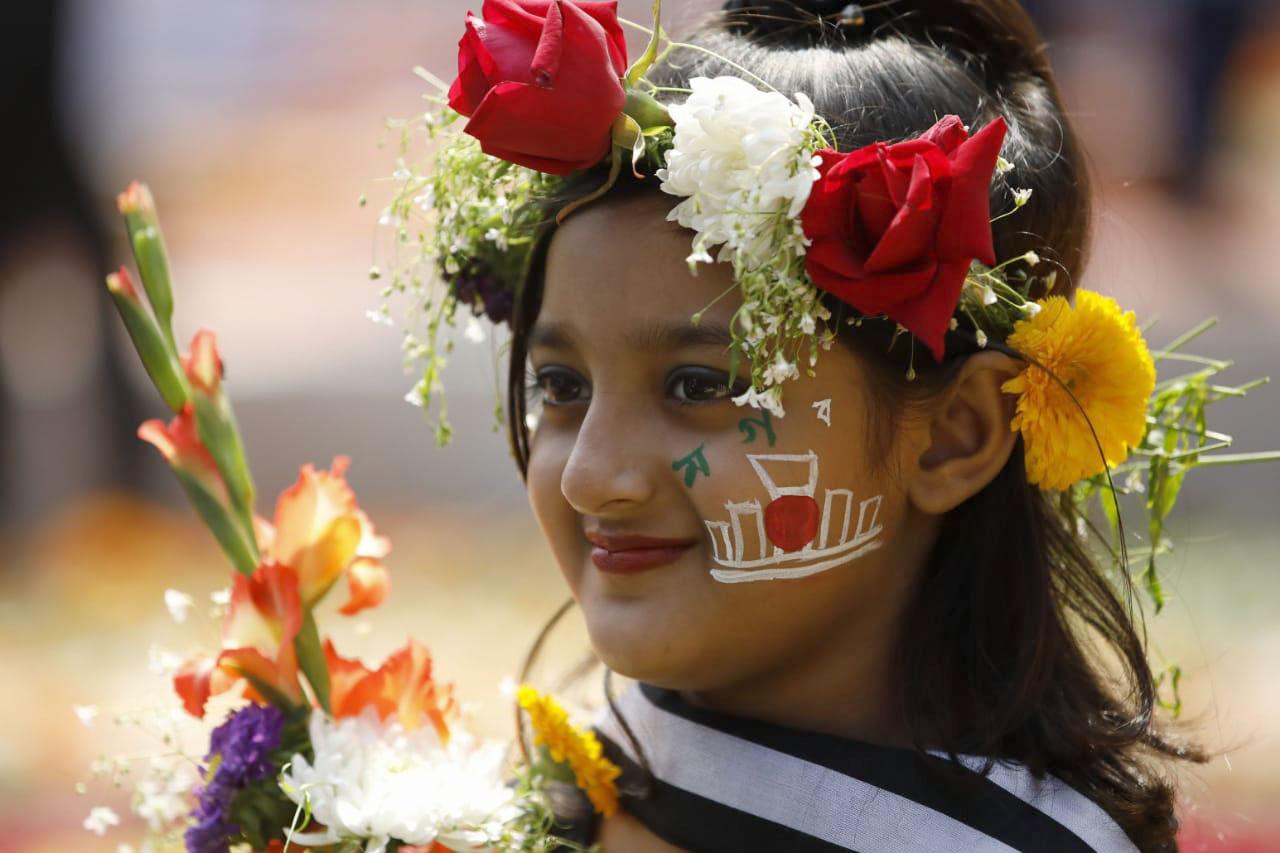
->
[705,451,883,584]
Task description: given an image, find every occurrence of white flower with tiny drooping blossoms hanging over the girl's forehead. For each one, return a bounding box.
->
[658,77,835,418]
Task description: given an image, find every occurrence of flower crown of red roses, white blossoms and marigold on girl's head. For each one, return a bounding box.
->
[372,0,1274,612]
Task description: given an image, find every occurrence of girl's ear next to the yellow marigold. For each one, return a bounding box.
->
[908,352,1021,515]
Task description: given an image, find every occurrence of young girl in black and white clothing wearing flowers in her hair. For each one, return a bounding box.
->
[422,0,1198,853]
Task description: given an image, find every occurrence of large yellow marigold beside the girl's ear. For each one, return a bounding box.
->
[1004,291,1156,491]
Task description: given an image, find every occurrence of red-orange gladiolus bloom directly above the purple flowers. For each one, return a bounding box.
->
[173,562,303,717]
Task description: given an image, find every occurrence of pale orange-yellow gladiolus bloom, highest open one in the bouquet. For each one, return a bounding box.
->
[255,456,390,616]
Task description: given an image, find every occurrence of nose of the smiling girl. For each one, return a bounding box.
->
[561,392,658,516]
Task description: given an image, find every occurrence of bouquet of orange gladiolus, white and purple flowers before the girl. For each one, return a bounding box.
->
[79,183,618,853]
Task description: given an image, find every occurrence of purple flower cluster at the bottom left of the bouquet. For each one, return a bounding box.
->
[186,704,284,853]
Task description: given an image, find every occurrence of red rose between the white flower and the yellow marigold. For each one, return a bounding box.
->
[801,115,1007,361]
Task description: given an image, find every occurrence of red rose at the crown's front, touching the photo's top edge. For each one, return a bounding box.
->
[449,0,627,175]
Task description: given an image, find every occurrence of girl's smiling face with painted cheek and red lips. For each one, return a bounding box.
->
[529,193,929,690]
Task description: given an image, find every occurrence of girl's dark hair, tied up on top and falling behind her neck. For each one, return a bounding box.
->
[508,0,1203,850]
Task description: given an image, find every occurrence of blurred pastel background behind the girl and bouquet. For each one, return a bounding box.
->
[0,0,1280,852]
